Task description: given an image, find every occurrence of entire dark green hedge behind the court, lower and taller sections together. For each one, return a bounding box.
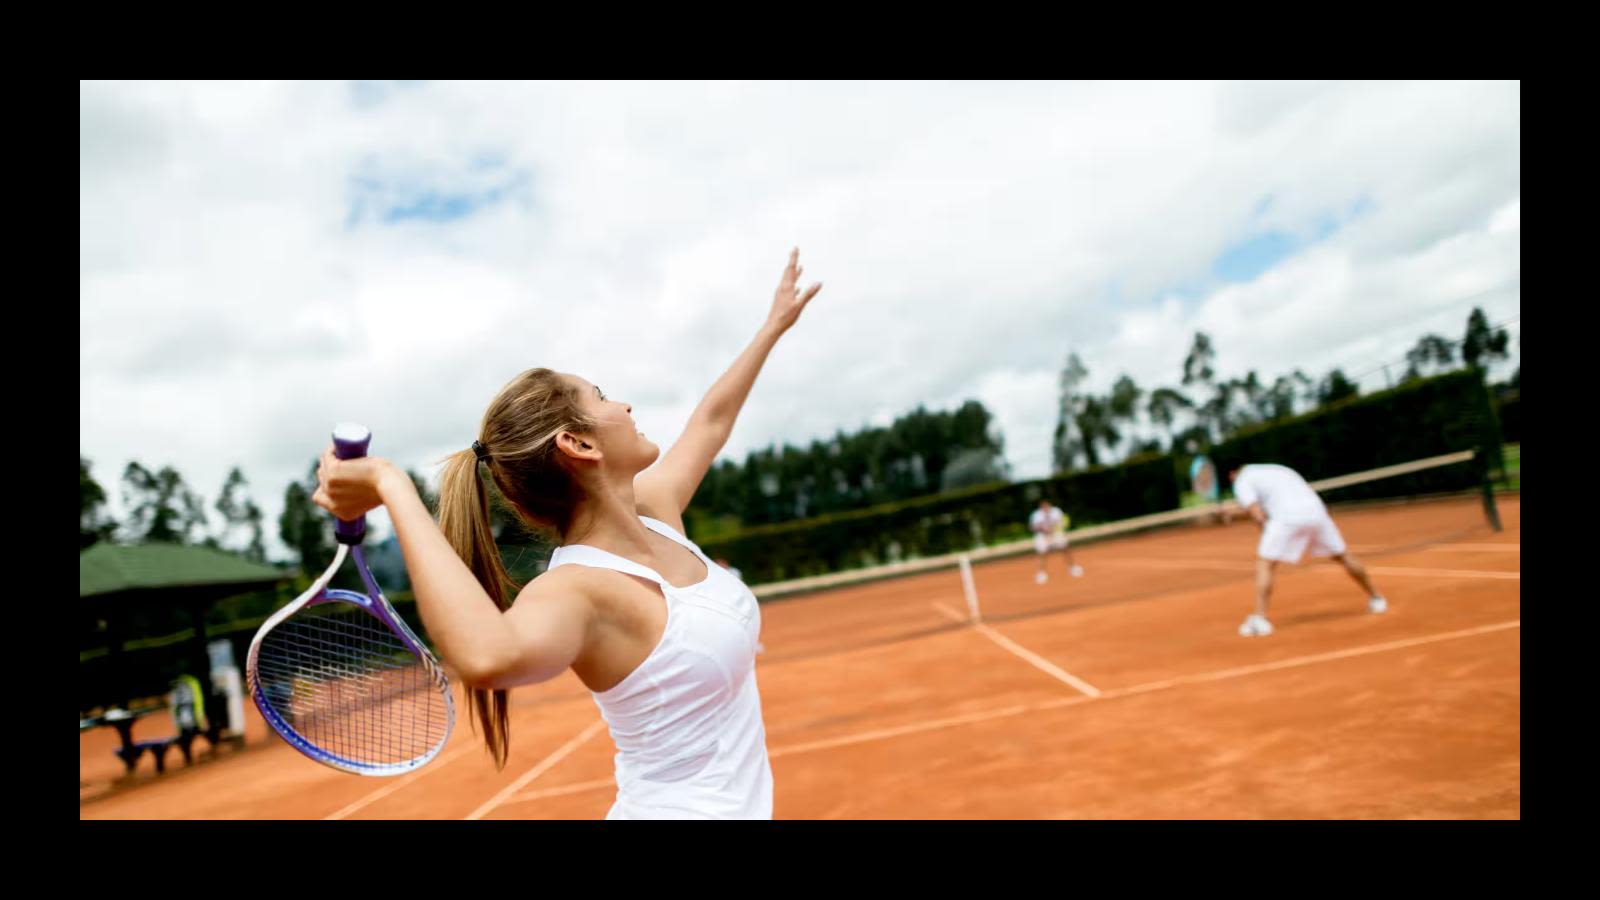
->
[691,372,1502,585]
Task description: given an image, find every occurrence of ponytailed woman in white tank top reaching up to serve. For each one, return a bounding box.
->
[315,250,822,818]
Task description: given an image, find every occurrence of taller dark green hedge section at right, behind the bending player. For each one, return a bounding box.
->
[1211,372,1502,501]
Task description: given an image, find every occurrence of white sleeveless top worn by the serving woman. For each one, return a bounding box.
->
[550,516,773,818]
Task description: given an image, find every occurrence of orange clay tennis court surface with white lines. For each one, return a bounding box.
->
[78,495,1522,818]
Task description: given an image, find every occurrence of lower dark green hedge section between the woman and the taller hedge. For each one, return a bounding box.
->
[691,456,1179,585]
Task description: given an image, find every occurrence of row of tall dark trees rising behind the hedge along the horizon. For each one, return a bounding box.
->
[78,309,1522,577]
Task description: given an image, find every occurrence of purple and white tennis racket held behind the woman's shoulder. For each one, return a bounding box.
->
[246,423,456,775]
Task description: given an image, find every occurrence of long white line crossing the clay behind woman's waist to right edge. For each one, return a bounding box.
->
[483,620,1522,799]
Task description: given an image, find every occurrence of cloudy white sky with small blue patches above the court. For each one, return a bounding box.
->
[78,82,1522,556]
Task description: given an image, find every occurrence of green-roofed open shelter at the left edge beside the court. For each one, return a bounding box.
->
[78,543,291,703]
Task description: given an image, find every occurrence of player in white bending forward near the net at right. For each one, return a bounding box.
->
[1227,464,1389,637]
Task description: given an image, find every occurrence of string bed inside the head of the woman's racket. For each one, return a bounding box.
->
[256,604,451,765]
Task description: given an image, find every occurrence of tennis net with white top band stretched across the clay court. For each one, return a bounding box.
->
[754,450,1499,660]
